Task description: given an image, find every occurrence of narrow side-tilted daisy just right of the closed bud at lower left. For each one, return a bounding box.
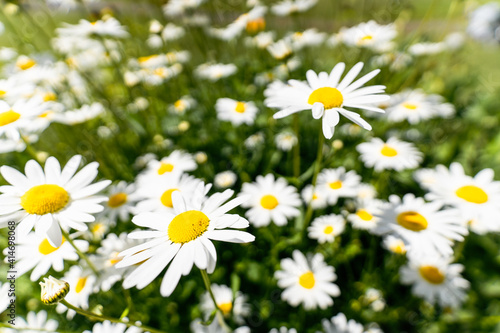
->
[56,265,96,319]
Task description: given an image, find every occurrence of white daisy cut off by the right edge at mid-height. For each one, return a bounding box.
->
[425,162,500,233]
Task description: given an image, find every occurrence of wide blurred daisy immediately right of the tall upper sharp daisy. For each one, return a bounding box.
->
[386,89,455,125]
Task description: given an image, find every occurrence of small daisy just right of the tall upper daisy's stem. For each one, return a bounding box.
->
[316,167,361,205]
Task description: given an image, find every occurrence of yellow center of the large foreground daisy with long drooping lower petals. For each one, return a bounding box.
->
[168,210,210,244]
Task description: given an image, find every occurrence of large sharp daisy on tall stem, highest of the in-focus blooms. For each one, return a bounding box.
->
[265,62,389,139]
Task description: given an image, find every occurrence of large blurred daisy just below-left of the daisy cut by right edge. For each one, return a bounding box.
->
[373,193,467,256]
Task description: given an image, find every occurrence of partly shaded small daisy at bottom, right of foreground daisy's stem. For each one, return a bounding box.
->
[200,284,250,324]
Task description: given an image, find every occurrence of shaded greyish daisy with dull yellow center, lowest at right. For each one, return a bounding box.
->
[399,255,470,307]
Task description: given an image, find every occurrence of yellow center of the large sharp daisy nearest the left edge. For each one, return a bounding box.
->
[21,184,69,215]
